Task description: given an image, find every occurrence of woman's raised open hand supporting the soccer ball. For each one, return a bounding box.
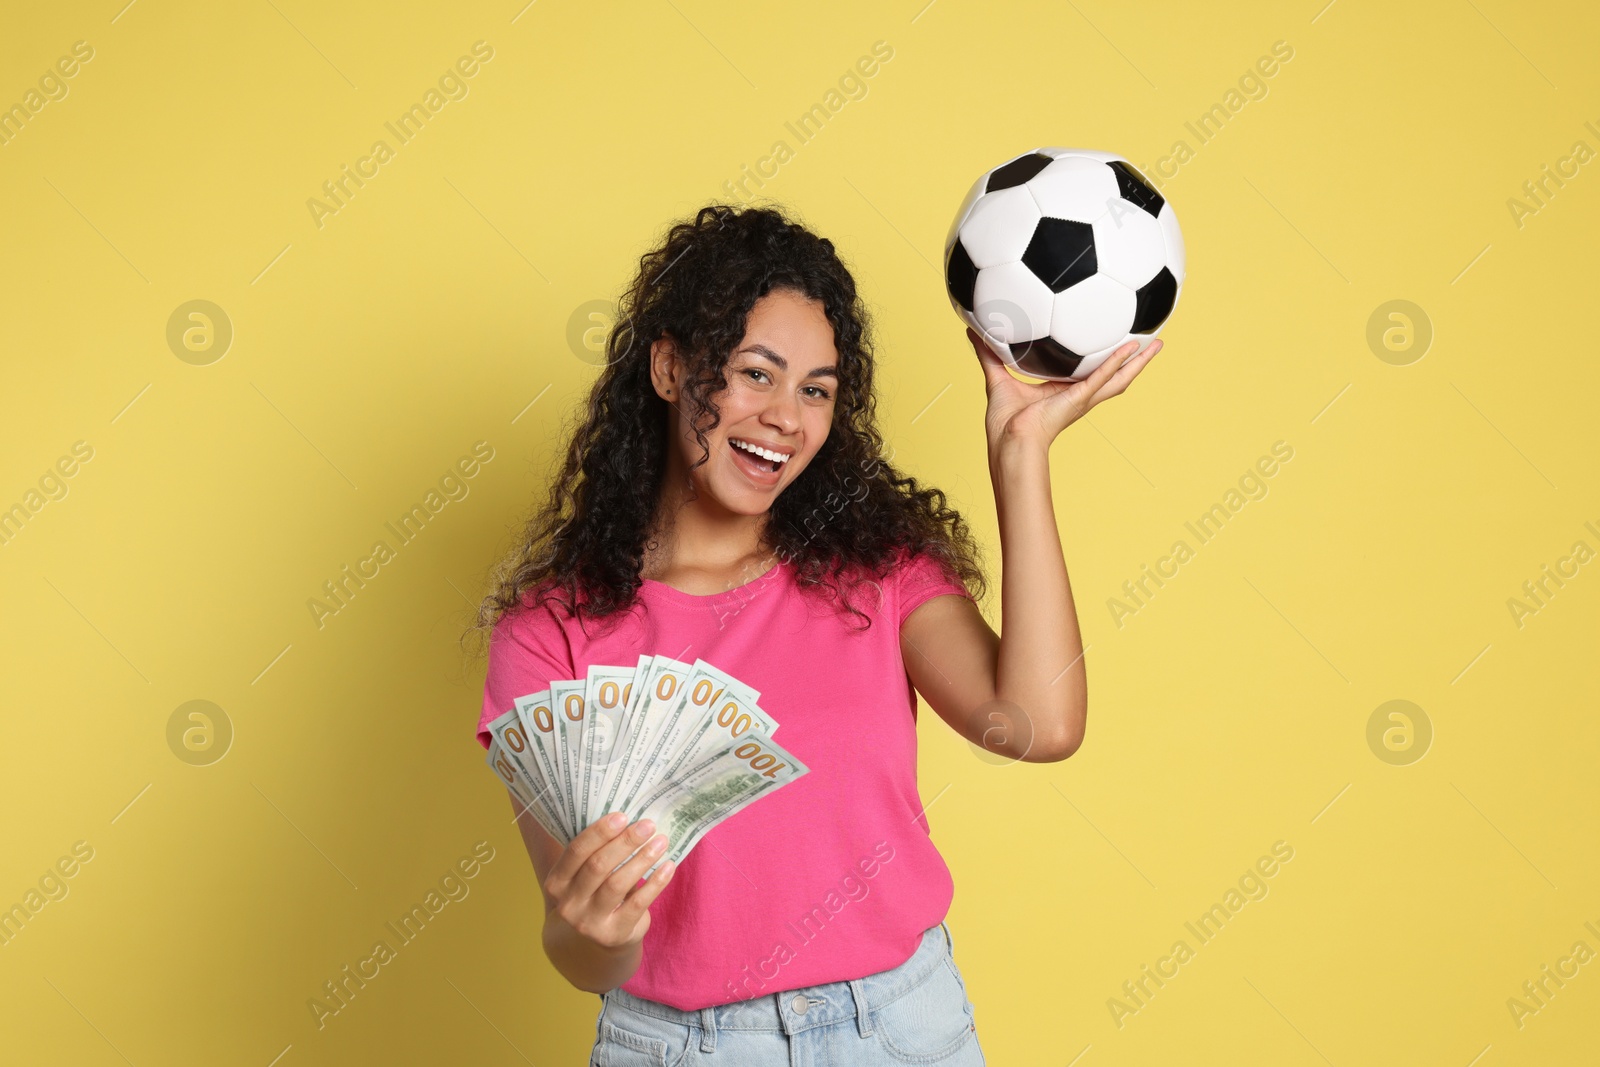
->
[966,326,1162,456]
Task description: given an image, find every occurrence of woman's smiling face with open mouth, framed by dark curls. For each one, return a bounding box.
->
[651,290,838,515]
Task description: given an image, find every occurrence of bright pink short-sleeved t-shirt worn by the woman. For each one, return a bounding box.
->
[478,557,970,1011]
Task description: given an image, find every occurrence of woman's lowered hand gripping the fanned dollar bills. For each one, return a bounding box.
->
[544,811,675,952]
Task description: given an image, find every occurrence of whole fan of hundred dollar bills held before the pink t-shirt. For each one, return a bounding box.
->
[488,656,808,870]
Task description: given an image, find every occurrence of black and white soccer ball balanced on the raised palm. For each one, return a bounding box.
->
[944,149,1184,381]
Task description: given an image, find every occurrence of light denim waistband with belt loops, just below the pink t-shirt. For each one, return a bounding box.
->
[603,921,954,1045]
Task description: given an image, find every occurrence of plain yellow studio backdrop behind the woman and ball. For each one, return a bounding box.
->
[0,0,1600,1067]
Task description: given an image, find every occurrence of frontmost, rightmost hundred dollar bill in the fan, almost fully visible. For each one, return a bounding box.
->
[629,729,810,877]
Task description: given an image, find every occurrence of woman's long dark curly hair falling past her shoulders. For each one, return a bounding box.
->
[469,203,987,646]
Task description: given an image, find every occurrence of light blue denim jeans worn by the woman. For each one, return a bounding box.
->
[589,923,984,1067]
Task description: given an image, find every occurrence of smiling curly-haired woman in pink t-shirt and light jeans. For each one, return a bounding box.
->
[478,205,1160,1067]
